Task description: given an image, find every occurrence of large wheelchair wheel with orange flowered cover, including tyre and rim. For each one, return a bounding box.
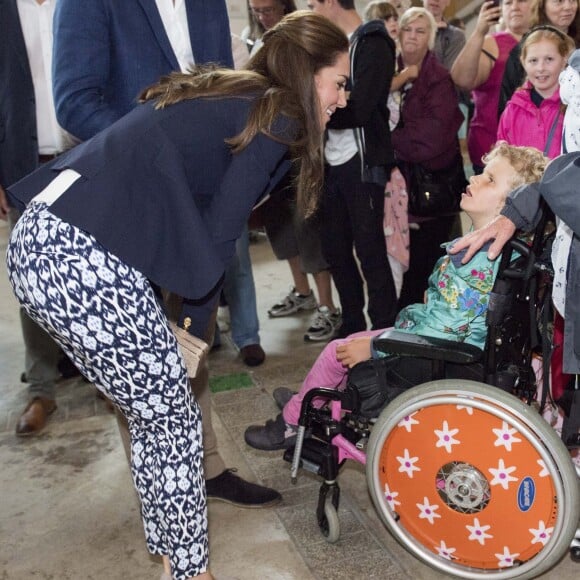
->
[367,380,580,580]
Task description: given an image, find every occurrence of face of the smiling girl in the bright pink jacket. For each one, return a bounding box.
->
[523,39,566,99]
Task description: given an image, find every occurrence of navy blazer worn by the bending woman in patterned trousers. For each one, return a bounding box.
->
[8,97,293,308]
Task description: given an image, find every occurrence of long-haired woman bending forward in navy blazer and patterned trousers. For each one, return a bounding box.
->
[7,12,349,580]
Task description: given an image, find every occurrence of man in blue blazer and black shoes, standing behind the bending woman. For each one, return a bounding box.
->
[53,0,280,507]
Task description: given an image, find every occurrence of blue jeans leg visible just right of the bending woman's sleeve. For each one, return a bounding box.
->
[223,225,260,348]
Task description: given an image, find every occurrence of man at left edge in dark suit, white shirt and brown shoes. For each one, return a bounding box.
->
[0,0,84,436]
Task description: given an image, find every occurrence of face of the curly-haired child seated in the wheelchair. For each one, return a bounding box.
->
[461,155,516,229]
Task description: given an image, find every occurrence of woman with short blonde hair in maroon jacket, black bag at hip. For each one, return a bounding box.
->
[391,8,465,308]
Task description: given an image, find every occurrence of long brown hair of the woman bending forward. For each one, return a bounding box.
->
[140,11,348,216]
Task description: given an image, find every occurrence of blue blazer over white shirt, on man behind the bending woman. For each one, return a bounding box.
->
[53,0,233,140]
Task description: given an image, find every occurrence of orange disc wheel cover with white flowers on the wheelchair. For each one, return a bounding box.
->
[377,404,558,570]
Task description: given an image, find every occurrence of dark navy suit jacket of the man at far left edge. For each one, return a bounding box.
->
[0,0,38,188]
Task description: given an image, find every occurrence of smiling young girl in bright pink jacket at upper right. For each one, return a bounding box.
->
[497,26,574,159]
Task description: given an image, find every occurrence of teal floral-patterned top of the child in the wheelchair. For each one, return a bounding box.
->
[386,242,499,348]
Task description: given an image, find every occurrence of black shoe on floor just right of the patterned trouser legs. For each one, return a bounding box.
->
[205,469,282,508]
